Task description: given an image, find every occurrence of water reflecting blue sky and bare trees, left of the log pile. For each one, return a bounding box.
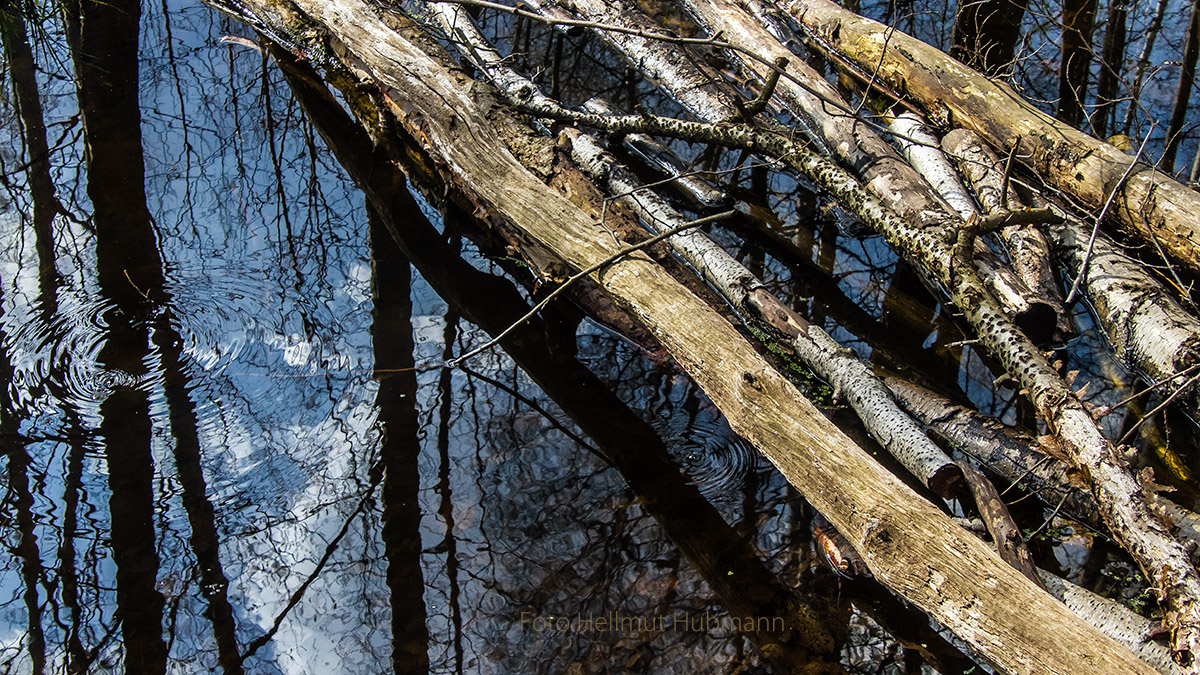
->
[0,1,988,673]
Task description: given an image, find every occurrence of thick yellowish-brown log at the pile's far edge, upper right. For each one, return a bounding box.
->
[785,0,1200,276]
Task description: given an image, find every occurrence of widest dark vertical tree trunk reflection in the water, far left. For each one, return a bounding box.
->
[64,0,167,674]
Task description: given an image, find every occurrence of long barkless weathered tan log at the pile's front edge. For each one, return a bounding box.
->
[211,0,1151,673]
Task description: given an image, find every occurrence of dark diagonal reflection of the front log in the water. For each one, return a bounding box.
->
[272,47,838,671]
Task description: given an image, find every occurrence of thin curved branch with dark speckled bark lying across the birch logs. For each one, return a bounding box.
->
[516,0,1200,665]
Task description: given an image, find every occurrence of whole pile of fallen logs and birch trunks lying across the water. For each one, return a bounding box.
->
[211,0,1200,673]
